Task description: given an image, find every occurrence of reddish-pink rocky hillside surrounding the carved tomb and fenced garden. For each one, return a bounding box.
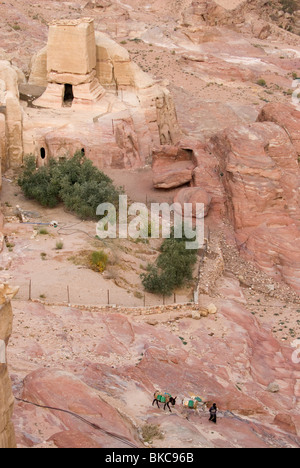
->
[0,0,300,448]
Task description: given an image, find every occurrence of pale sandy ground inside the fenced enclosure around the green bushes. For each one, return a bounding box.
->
[0,175,197,306]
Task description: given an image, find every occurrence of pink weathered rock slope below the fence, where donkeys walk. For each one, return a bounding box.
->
[9,296,300,447]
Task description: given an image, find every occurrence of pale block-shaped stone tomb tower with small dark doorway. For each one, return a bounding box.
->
[36,18,105,108]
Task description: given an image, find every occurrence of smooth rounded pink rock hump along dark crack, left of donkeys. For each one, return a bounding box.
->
[23,369,139,448]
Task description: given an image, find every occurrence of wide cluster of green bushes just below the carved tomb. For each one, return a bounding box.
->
[18,152,121,219]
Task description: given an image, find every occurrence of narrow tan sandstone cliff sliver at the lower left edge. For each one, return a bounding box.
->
[0,284,16,448]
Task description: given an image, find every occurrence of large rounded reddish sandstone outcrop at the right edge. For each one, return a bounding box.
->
[212,122,300,292]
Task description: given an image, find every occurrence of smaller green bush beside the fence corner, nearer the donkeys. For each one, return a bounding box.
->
[141,230,197,296]
